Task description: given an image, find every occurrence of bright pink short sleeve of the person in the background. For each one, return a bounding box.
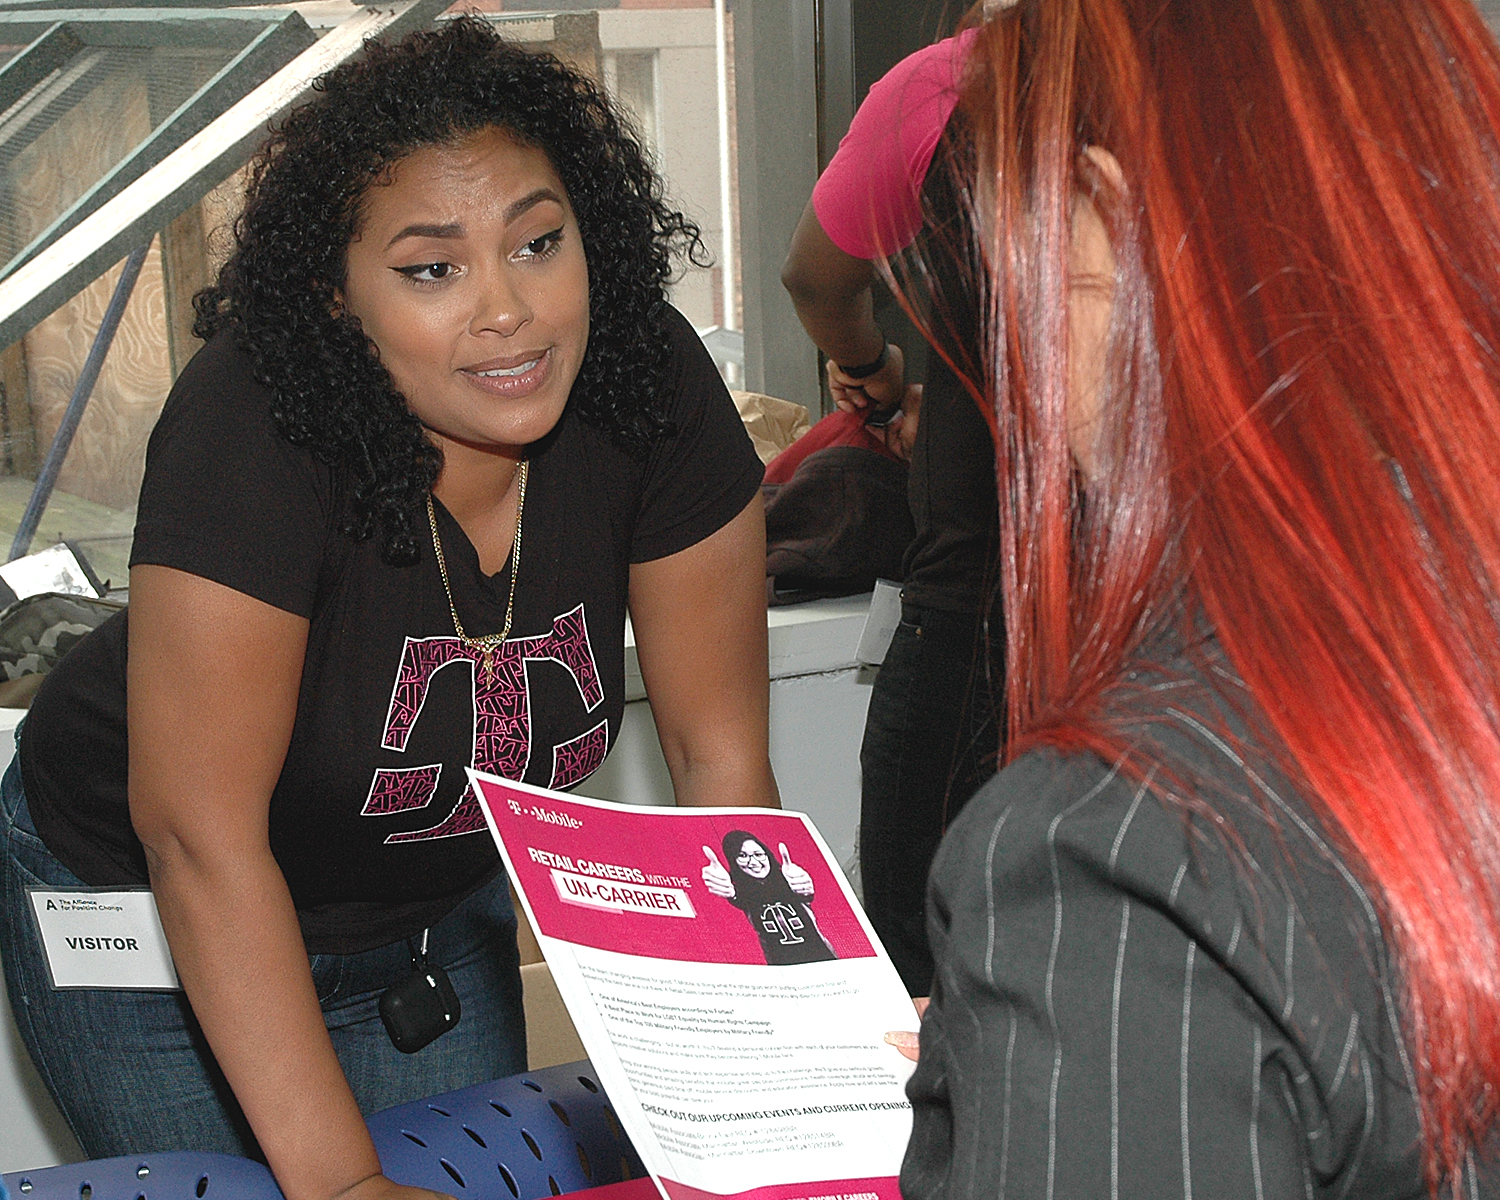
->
[813,30,977,260]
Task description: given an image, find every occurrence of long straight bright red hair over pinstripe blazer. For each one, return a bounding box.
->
[960,0,1500,1188]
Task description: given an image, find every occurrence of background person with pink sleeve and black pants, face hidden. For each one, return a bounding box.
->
[782,29,1004,996]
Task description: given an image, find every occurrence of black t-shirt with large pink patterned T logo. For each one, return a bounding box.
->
[20,312,762,953]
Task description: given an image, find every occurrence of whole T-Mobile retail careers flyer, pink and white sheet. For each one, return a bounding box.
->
[470,771,915,1200]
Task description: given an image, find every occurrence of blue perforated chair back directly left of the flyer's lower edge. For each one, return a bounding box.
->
[369,1059,647,1200]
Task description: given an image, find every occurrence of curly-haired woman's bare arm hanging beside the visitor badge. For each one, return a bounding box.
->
[128,566,393,1200]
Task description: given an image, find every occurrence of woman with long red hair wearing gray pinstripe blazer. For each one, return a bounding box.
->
[902,0,1500,1200]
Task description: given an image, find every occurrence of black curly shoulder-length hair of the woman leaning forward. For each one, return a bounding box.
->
[194,17,707,564]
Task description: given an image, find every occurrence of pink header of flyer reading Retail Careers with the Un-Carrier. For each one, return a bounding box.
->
[477,779,875,966]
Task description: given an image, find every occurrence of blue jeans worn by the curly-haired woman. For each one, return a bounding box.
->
[0,762,527,1158]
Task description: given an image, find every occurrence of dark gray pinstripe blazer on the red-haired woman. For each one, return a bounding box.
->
[902,648,1496,1200]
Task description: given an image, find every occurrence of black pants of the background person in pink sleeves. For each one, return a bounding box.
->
[860,603,1004,996]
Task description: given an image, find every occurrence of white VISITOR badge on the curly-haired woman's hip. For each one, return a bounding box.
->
[29,888,182,992]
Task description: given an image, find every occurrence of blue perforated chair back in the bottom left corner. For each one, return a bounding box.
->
[0,1151,282,1200]
